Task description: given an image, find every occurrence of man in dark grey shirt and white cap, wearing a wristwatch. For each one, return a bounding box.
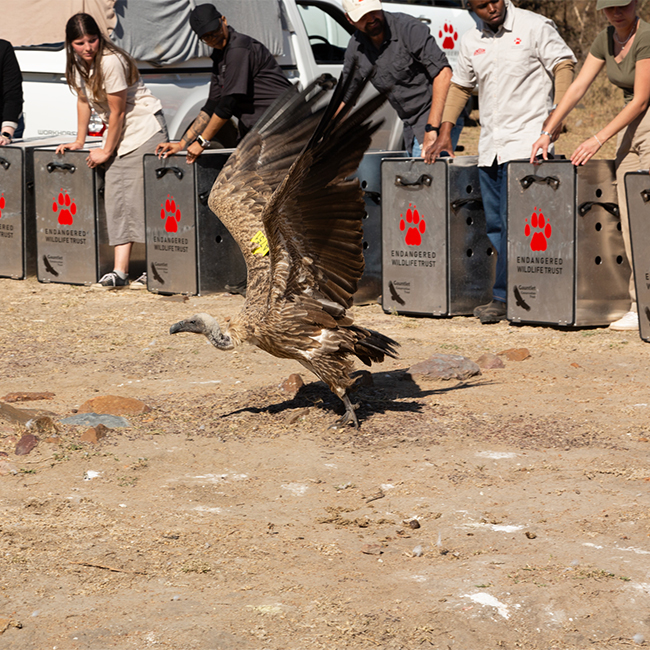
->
[343,0,452,162]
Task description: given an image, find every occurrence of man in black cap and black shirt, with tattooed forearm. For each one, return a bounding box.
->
[156,4,291,163]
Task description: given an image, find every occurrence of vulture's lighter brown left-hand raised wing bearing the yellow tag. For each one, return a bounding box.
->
[208,75,334,274]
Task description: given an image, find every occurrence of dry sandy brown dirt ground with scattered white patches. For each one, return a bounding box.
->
[0,279,650,650]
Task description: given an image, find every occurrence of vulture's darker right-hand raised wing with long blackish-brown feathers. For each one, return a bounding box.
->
[263,73,385,312]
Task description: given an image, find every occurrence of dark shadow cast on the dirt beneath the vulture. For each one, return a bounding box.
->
[221,369,494,421]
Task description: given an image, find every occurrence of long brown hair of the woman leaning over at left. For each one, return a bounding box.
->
[65,13,140,103]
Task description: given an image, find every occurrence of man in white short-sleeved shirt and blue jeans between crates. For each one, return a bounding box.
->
[434,0,576,323]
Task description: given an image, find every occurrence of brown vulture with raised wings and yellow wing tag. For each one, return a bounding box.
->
[170,75,399,428]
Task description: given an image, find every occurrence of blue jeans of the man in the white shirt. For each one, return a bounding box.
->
[478,159,508,302]
